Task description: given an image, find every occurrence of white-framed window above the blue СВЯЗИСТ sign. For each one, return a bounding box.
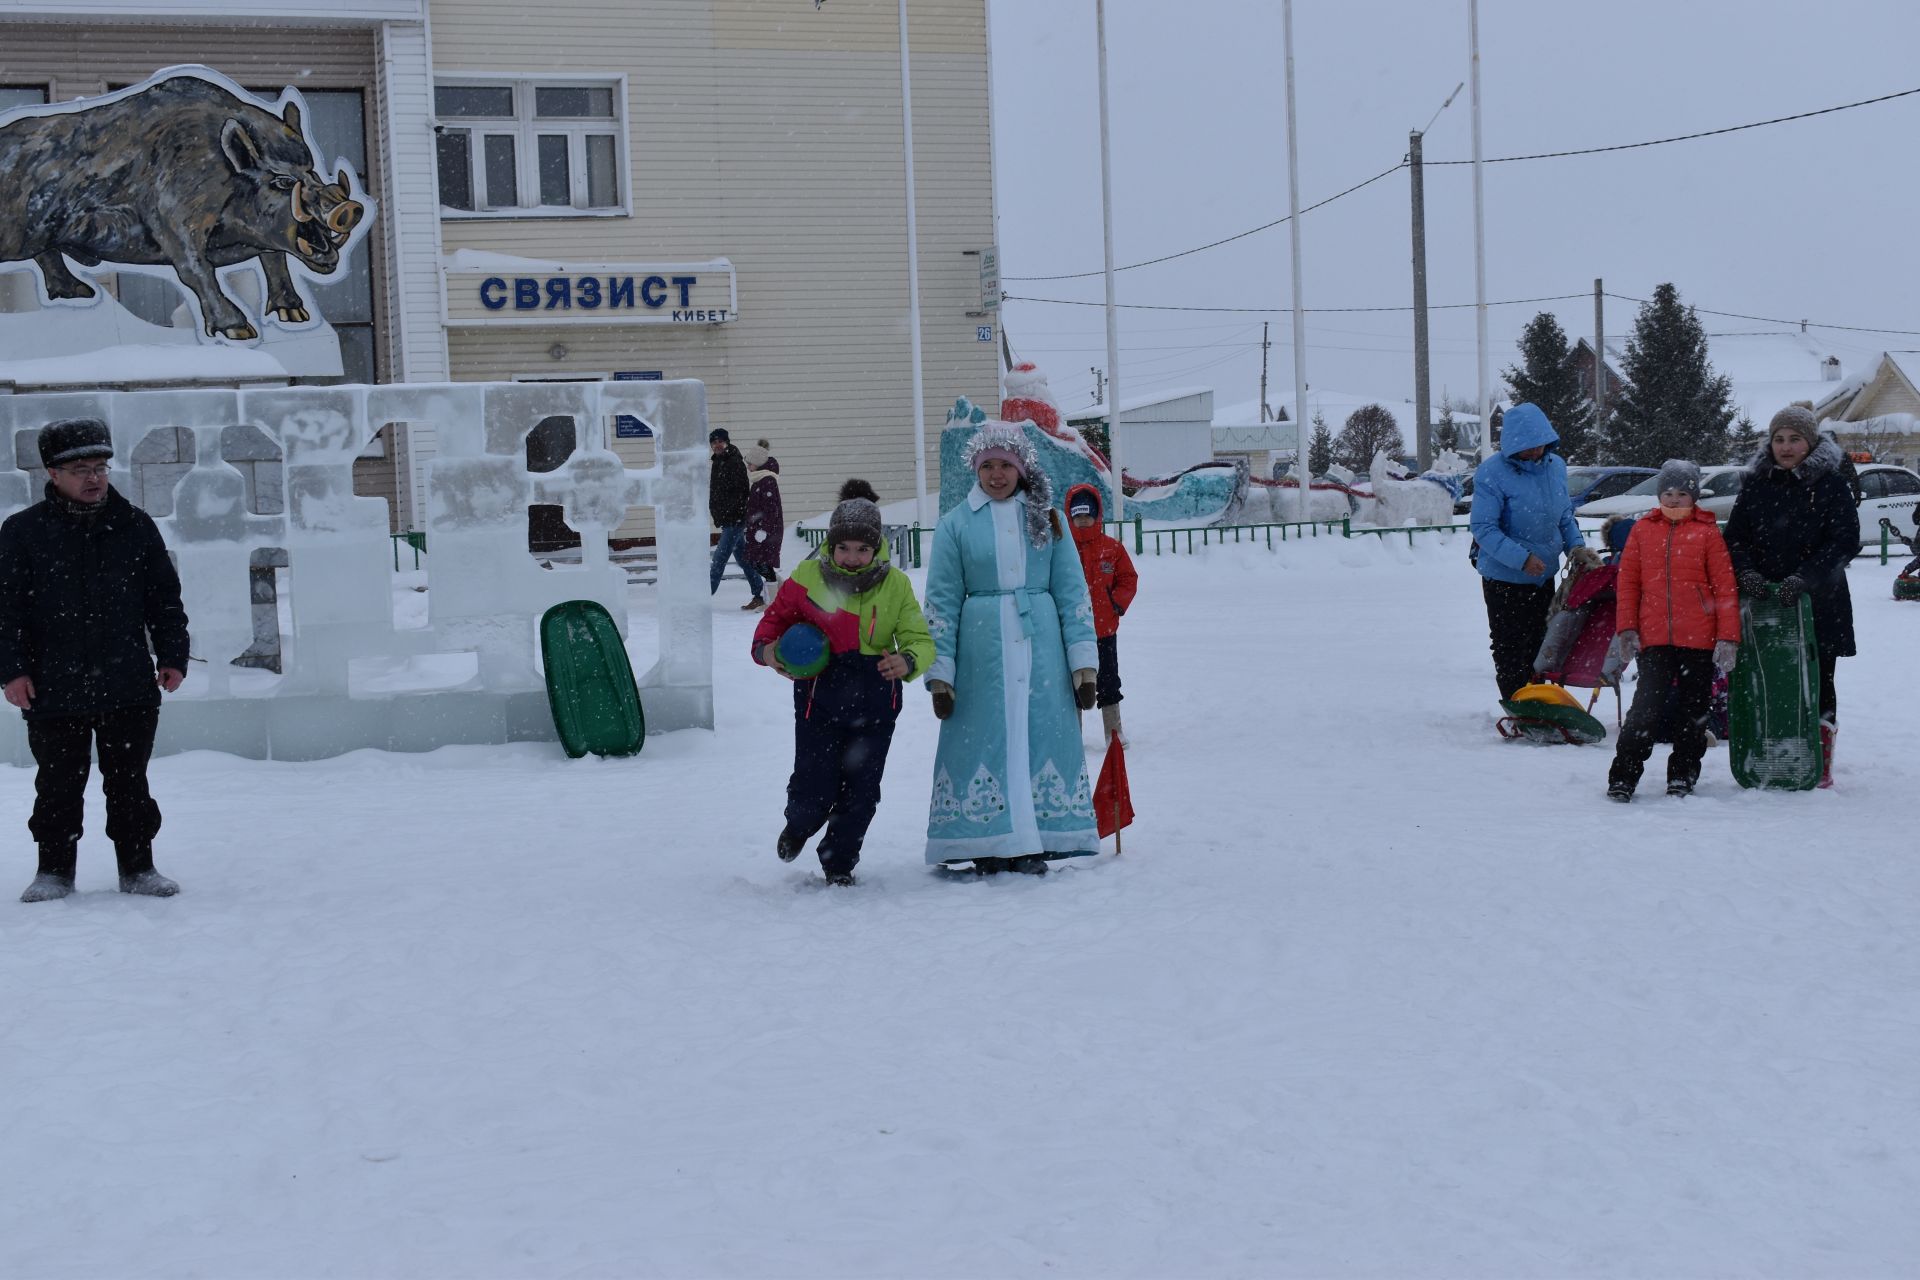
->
[434,79,626,217]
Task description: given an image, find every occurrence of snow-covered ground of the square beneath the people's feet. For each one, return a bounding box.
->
[0,537,1920,1276]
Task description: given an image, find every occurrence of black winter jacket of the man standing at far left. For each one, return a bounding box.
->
[0,486,188,720]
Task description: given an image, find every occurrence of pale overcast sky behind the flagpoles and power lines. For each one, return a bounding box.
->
[989,0,1920,420]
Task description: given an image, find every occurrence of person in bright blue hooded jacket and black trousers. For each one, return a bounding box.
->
[1471,405,1599,700]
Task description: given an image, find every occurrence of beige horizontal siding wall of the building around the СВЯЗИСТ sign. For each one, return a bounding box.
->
[432,0,998,533]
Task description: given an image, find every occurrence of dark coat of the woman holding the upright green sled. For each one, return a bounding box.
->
[1726,439,1860,658]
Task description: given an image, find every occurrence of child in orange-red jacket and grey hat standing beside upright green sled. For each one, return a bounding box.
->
[1607,459,1740,804]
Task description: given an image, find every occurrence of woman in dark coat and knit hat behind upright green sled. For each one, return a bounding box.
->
[1726,405,1860,787]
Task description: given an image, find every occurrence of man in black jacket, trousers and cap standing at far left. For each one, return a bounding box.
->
[0,418,188,902]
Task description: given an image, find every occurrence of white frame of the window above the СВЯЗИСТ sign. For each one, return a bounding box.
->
[434,71,634,221]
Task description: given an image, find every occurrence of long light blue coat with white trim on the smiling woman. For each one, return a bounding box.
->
[925,484,1100,864]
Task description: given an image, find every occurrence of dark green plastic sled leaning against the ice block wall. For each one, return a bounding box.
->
[540,601,647,760]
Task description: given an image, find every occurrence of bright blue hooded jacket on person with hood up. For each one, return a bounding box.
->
[1469,405,1586,587]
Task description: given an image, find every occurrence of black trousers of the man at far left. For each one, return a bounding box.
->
[27,706,159,879]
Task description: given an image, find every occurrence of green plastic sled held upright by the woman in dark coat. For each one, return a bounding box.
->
[1726,595,1820,791]
